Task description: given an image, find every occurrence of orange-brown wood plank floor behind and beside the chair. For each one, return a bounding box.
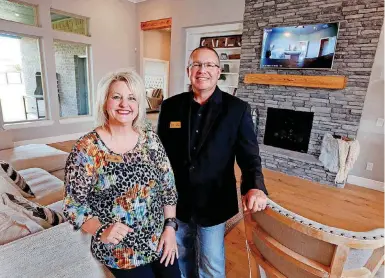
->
[51,141,384,278]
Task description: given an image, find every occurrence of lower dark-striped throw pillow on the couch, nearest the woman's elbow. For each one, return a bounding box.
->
[1,193,65,228]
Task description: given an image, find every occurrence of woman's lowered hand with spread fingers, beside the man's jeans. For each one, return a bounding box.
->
[157,226,179,267]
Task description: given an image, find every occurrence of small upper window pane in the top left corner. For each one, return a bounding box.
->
[0,0,37,25]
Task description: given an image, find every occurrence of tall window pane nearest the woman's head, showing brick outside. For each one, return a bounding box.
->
[54,41,90,118]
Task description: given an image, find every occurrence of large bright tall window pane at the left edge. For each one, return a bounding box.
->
[0,33,46,123]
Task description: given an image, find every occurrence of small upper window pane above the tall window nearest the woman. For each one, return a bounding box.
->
[51,11,88,36]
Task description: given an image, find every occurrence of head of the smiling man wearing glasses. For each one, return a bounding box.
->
[187,49,221,92]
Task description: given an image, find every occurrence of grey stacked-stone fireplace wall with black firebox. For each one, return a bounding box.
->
[237,0,384,185]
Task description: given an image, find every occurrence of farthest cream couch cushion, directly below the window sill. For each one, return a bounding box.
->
[0,144,68,172]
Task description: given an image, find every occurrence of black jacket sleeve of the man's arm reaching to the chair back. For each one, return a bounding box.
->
[235,104,268,195]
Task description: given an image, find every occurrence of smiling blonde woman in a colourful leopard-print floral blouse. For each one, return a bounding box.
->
[64,70,180,278]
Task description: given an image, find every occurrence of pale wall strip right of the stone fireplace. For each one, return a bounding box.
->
[351,28,384,182]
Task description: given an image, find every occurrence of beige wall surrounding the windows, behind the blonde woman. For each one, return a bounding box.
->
[0,0,138,141]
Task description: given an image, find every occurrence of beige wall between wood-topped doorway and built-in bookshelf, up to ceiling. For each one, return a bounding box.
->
[137,0,245,96]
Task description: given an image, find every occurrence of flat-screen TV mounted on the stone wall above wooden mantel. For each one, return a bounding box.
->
[261,22,339,69]
